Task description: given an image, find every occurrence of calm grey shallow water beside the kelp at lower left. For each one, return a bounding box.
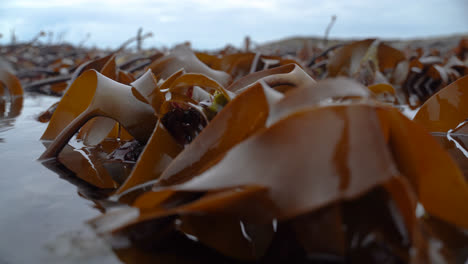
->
[0,95,121,264]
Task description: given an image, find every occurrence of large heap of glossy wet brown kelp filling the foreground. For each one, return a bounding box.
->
[0,39,468,263]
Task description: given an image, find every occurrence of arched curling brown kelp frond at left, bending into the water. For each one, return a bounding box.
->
[41,70,156,158]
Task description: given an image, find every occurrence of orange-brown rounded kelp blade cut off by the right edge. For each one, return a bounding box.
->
[413,76,468,132]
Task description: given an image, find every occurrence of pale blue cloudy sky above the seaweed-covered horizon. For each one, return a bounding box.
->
[0,0,468,49]
